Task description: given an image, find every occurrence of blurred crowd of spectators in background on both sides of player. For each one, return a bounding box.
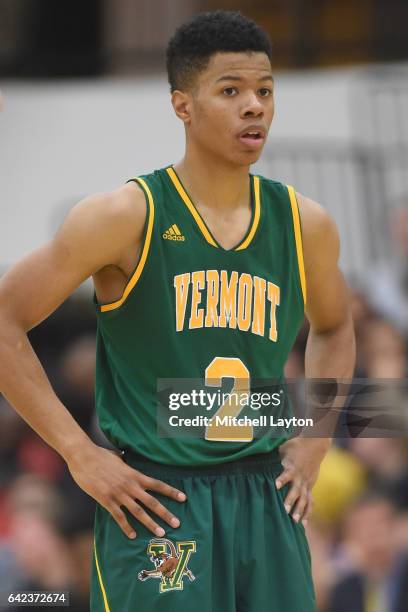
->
[0,209,408,612]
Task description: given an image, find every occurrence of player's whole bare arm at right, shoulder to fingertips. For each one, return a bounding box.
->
[276,194,355,523]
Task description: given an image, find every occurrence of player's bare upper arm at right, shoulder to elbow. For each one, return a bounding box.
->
[297,194,350,333]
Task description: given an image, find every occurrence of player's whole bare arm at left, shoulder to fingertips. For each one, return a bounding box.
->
[0,183,185,537]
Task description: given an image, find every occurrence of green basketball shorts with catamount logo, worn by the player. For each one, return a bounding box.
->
[91,451,316,612]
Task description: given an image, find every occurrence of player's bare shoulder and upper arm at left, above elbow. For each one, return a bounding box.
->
[0,183,146,331]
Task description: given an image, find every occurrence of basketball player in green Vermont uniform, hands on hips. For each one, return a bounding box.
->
[0,11,354,612]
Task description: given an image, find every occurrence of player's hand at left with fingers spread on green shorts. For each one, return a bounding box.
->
[68,444,186,538]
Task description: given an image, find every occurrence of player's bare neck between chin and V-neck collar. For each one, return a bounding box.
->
[174,150,250,211]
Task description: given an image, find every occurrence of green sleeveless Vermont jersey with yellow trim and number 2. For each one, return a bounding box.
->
[94,166,306,465]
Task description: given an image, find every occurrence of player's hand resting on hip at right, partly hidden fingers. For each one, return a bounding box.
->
[275,437,331,525]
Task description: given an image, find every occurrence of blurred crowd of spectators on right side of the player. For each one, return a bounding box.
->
[287,207,408,612]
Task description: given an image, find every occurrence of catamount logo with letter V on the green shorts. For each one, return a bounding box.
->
[138,538,197,593]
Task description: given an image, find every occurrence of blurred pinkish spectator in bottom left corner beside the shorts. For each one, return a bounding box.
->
[0,475,92,612]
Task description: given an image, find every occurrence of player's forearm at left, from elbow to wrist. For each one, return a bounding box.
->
[0,317,92,461]
